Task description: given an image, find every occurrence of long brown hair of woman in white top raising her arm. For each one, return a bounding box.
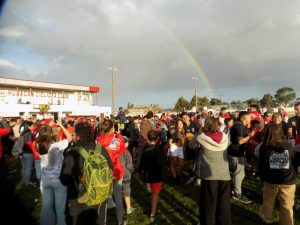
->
[37,125,53,155]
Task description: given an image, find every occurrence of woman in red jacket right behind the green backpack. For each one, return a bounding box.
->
[97,120,127,225]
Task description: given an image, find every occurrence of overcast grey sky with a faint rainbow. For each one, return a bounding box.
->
[0,0,300,107]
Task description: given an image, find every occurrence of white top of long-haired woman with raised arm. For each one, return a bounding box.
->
[41,139,69,180]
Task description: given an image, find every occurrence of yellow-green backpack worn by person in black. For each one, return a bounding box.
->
[76,144,113,206]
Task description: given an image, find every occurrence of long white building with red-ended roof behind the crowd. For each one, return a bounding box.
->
[0,77,111,117]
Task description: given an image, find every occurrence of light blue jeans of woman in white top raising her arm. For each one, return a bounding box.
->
[40,179,67,225]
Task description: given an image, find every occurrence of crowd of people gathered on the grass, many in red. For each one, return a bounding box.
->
[0,102,300,225]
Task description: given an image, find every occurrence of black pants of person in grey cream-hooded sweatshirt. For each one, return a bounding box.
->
[199,180,231,225]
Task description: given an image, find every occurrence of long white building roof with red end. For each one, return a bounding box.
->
[0,77,100,93]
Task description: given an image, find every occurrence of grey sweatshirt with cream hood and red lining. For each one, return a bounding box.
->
[195,132,230,181]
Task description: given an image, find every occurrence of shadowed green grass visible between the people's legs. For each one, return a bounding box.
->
[7,156,300,225]
